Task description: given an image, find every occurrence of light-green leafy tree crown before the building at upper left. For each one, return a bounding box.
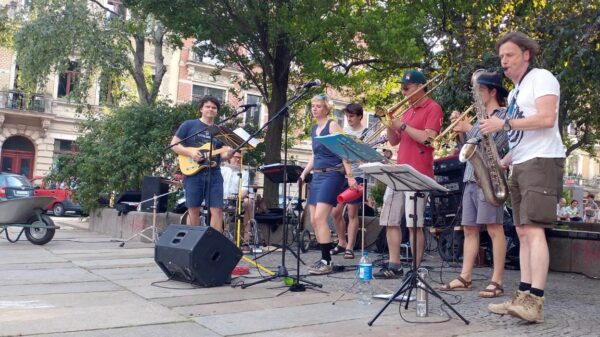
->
[14,0,167,104]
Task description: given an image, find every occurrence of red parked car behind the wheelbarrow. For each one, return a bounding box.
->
[31,177,81,216]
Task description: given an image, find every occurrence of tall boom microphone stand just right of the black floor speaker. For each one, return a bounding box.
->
[235,86,323,291]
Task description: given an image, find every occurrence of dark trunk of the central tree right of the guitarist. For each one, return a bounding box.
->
[264,39,291,207]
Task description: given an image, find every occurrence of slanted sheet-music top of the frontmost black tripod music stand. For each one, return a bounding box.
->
[358,163,448,192]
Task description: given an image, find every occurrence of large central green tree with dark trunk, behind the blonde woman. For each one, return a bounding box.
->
[125,0,424,204]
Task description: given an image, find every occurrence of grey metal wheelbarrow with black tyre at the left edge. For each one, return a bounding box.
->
[0,197,60,245]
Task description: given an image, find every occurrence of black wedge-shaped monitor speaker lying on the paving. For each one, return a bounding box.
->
[154,225,243,287]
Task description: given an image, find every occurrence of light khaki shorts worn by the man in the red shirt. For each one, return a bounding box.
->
[379,187,427,227]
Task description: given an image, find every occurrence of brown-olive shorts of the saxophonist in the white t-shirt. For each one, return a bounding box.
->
[510,158,565,227]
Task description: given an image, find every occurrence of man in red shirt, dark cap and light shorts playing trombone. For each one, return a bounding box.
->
[373,70,444,278]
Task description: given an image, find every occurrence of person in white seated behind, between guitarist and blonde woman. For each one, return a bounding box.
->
[221,152,254,254]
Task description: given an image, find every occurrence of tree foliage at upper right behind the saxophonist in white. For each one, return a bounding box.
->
[412,0,600,155]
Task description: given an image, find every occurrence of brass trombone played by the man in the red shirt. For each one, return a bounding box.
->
[363,74,444,146]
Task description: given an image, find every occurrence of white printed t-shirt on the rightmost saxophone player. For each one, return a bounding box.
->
[507,68,565,164]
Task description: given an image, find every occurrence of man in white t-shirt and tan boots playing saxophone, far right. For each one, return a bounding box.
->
[481,32,565,323]
